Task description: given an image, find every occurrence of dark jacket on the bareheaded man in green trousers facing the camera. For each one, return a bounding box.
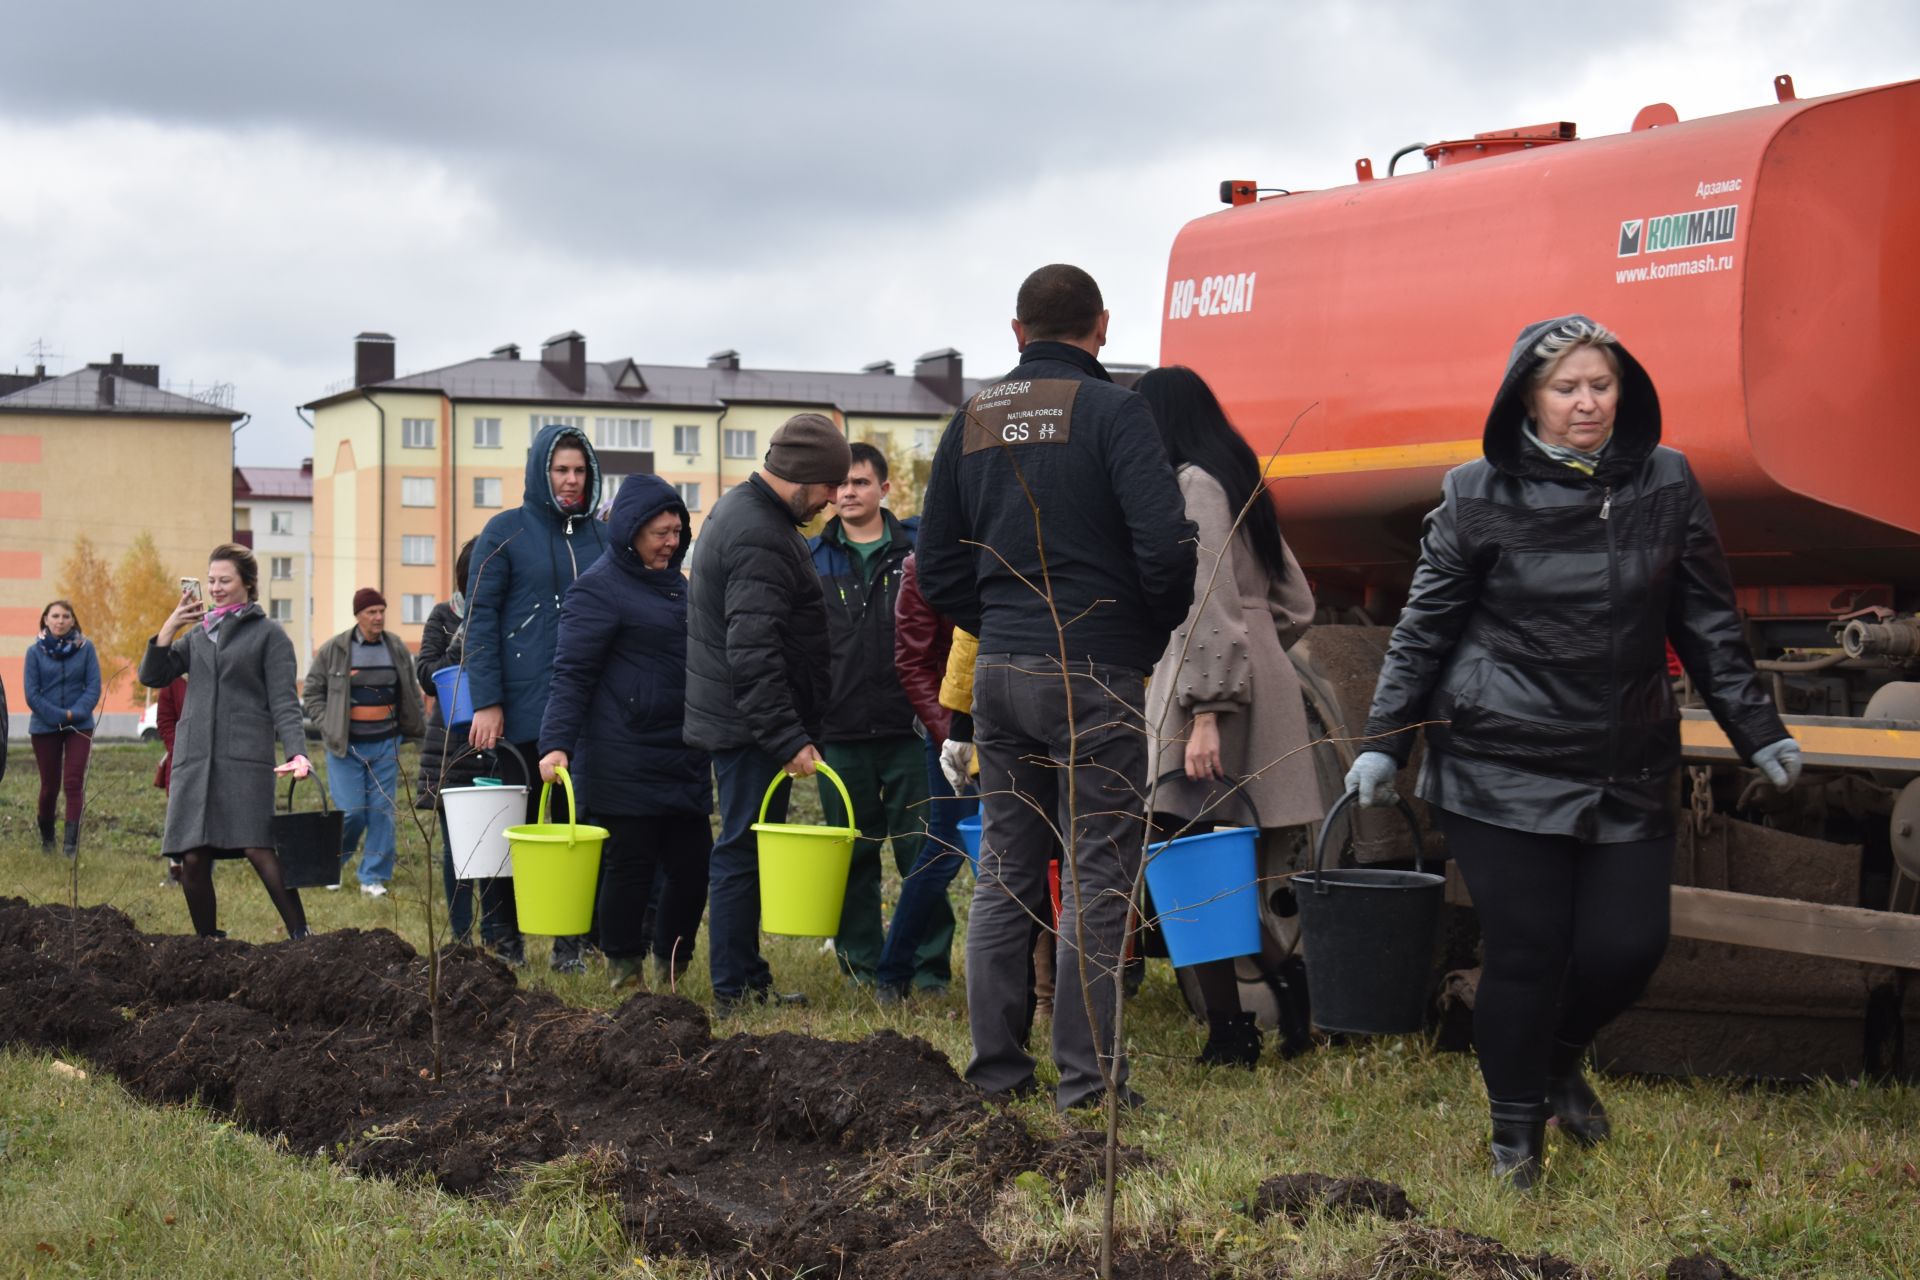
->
[806,509,920,743]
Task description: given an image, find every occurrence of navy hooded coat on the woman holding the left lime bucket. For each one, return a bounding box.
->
[540,476,712,816]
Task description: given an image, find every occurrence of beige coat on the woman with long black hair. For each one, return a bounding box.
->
[1146,464,1321,829]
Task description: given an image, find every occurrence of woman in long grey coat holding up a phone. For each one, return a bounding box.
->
[140,543,311,938]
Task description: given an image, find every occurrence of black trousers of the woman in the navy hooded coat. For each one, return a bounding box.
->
[593,814,714,973]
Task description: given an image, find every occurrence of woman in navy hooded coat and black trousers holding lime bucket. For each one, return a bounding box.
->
[540,476,712,988]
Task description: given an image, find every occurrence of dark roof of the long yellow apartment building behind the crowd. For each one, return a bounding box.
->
[305,357,981,416]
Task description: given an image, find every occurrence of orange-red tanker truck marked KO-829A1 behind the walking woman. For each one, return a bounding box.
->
[1160,77,1920,1077]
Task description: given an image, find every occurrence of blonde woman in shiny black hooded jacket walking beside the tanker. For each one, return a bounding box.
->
[1348,315,1799,1188]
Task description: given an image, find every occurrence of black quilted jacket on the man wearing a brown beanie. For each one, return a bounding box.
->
[685,472,833,760]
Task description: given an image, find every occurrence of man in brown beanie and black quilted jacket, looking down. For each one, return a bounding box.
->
[685,413,852,1009]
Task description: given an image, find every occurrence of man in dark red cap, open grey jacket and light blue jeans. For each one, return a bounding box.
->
[301,587,426,898]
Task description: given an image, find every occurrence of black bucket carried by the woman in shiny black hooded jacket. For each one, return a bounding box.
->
[1292,791,1446,1036]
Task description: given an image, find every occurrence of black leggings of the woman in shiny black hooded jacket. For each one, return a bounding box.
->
[1436,810,1674,1103]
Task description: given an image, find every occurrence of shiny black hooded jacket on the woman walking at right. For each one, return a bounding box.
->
[1367,317,1788,842]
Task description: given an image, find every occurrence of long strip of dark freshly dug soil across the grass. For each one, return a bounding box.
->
[0,898,1208,1280]
